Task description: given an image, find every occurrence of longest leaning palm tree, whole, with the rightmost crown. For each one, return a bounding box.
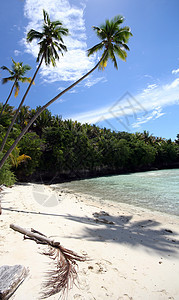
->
[0,16,132,168]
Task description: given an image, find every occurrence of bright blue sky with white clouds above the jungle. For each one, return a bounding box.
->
[0,0,179,140]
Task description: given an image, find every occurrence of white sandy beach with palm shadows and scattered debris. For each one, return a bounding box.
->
[0,184,179,300]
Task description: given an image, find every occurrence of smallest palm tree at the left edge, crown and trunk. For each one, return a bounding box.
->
[0,59,31,117]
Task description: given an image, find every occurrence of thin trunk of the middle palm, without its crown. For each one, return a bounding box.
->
[0,55,44,151]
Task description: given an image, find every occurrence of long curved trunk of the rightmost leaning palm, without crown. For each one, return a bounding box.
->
[0,50,107,169]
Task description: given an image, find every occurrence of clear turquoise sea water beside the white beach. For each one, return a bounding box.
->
[56,169,179,216]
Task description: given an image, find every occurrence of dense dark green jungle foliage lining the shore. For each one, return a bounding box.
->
[0,104,179,185]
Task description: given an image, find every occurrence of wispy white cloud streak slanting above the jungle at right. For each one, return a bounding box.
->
[69,79,179,127]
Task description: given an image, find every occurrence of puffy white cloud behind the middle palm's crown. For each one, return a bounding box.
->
[23,0,95,82]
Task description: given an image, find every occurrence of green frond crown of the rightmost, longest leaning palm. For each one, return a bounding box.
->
[88,16,132,69]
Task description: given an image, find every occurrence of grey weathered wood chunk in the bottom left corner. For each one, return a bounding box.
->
[0,265,28,300]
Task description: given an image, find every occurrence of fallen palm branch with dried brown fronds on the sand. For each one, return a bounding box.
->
[10,224,87,299]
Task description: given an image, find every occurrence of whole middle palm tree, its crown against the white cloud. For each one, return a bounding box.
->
[0,10,68,151]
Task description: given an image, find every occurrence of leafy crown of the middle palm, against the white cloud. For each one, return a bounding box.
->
[27,10,68,66]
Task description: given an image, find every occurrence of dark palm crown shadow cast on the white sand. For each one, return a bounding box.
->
[66,213,179,255]
